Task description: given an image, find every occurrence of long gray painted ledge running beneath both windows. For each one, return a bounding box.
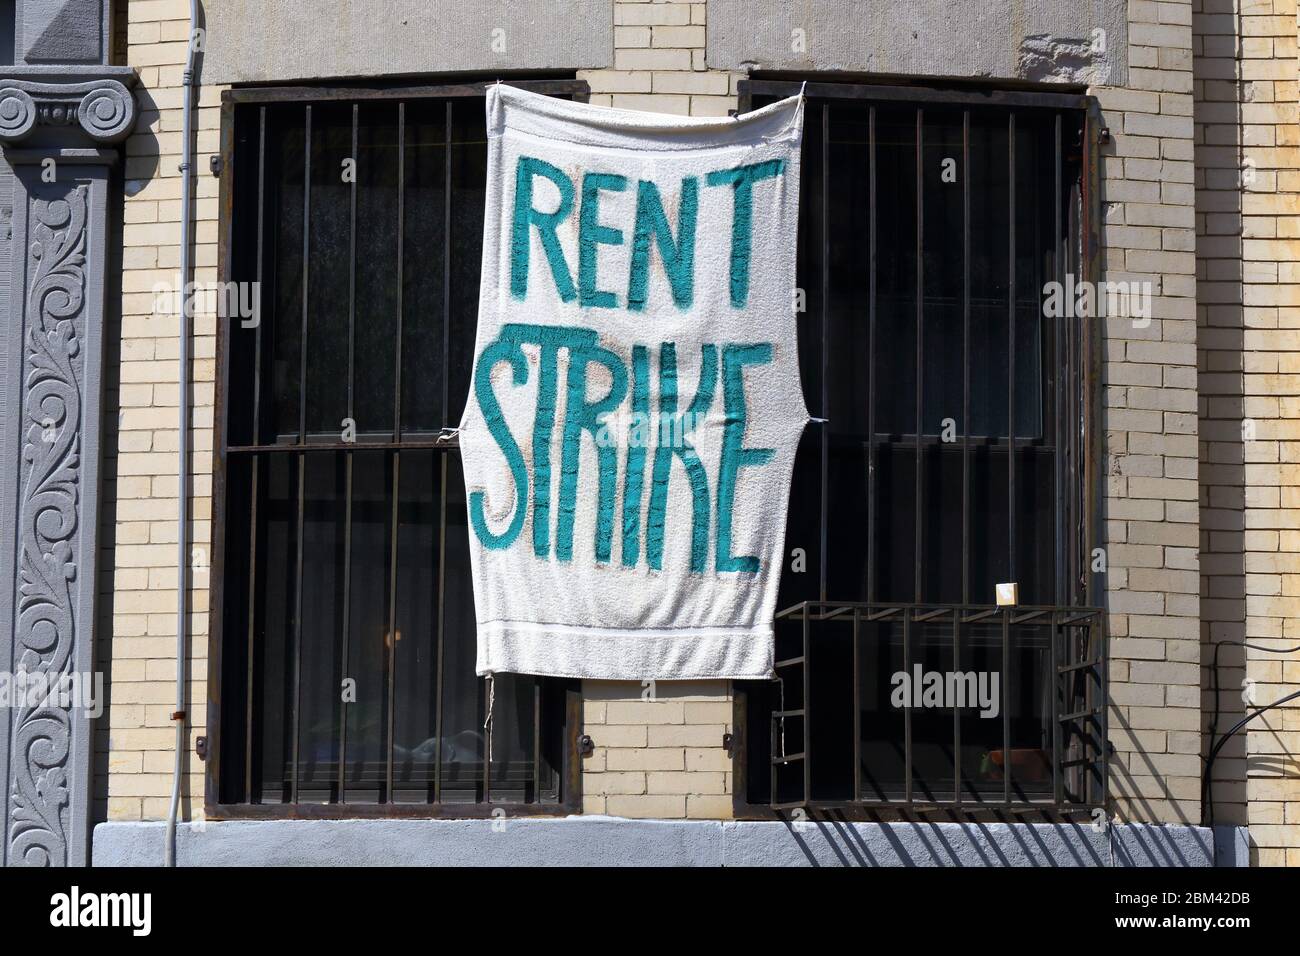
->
[94,817,1247,866]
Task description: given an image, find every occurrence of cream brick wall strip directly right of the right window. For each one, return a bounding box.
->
[1091,0,1201,823]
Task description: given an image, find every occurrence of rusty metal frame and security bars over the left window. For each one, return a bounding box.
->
[204,78,589,818]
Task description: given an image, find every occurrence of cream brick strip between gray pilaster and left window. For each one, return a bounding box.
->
[98,0,221,819]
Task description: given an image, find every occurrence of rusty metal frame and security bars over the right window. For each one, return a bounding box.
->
[732,78,1110,818]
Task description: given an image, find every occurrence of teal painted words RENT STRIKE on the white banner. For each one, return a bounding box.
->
[469,156,785,574]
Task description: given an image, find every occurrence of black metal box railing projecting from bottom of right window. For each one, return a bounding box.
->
[771,601,1109,812]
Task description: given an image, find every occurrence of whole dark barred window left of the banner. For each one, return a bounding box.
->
[208,79,586,816]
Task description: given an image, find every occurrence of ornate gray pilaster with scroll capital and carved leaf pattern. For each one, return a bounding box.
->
[0,0,137,866]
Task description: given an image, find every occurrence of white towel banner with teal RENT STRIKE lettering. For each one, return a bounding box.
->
[460,85,809,680]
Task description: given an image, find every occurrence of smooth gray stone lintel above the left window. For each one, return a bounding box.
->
[203,0,614,83]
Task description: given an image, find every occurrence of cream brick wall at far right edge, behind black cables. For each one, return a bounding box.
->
[1195,0,1300,865]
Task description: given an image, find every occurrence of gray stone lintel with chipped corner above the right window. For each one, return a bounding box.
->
[707,0,1128,85]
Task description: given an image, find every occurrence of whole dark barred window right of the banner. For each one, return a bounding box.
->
[737,79,1108,810]
